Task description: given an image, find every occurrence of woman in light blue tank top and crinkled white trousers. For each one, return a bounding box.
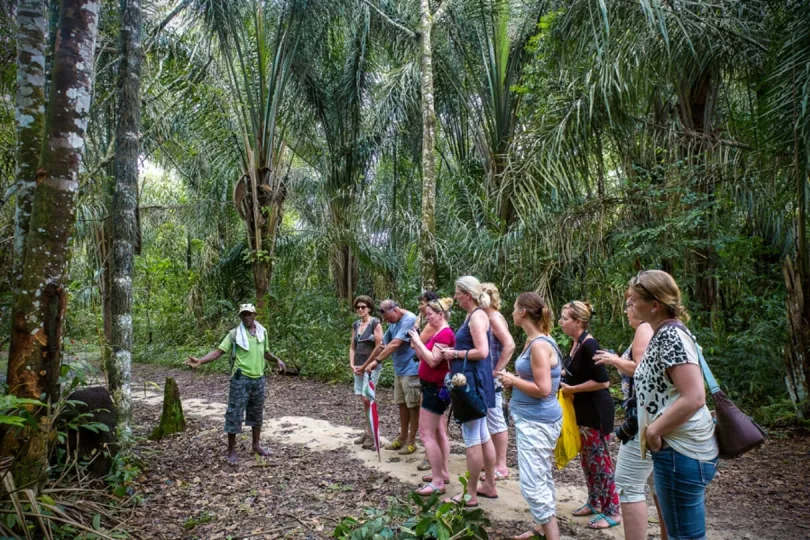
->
[498,292,562,540]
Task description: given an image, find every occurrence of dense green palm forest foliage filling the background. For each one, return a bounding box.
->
[0,0,810,450]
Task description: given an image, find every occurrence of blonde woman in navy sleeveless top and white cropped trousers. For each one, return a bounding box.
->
[441,276,498,507]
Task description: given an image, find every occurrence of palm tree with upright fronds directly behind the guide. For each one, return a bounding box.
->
[189,0,317,310]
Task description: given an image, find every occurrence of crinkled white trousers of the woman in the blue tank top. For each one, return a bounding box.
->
[511,412,562,525]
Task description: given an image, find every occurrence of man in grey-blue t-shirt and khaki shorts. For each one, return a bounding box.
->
[355,300,422,455]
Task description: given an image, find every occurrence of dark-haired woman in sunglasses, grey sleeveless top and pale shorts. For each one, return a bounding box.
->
[349,295,383,448]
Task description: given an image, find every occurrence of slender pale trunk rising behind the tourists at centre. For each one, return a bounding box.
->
[419,0,438,290]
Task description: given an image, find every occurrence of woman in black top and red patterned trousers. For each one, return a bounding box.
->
[559,300,621,529]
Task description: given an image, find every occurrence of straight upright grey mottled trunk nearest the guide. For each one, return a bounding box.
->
[106,0,142,449]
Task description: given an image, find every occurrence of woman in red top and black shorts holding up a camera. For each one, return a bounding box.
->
[408,298,456,497]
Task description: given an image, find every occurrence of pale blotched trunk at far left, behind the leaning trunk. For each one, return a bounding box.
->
[11,0,48,290]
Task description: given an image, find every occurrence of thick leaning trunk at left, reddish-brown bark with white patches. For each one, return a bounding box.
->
[2,0,100,487]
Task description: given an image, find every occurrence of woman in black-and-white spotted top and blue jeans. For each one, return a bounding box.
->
[629,270,719,540]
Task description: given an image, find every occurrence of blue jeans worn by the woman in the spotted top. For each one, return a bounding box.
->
[652,448,717,540]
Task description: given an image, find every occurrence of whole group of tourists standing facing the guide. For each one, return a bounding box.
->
[349,270,719,540]
